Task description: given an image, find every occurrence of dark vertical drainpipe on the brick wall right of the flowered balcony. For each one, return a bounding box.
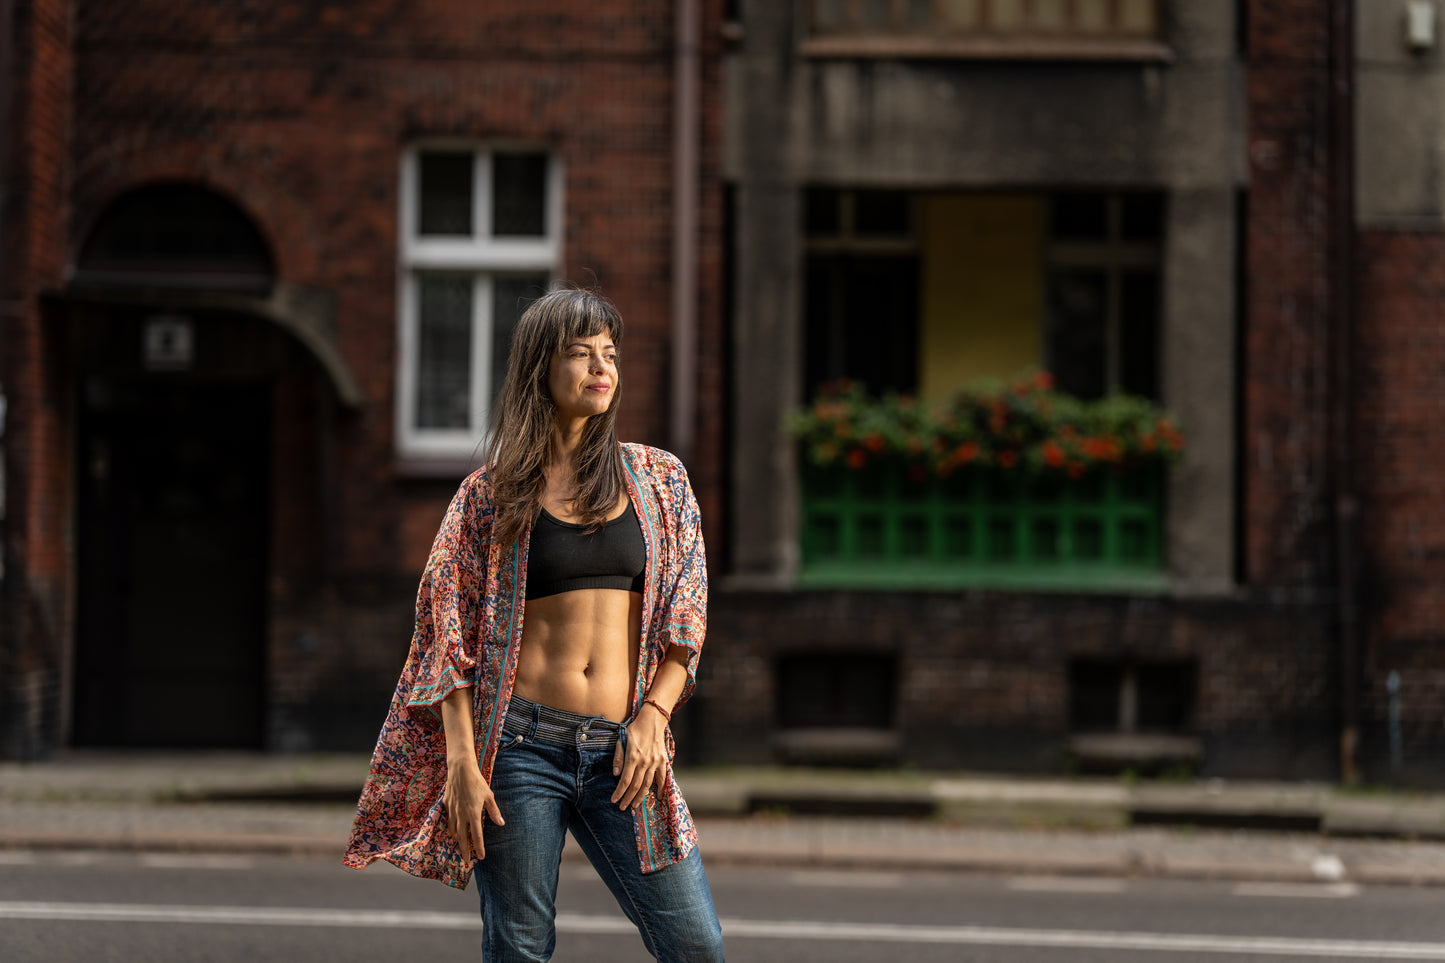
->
[1329,0,1360,785]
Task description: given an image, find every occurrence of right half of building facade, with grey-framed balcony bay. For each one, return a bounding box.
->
[708,0,1445,784]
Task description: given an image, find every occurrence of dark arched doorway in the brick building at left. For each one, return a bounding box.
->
[71,184,280,748]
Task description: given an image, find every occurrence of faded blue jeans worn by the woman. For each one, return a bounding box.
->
[475,697,723,963]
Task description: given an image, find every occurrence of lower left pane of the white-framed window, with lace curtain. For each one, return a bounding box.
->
[416,273,473,429]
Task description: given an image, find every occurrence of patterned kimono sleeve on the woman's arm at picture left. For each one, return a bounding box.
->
[403,471,491,717]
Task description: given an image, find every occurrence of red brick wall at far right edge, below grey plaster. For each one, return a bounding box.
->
[1354,230,1445,781]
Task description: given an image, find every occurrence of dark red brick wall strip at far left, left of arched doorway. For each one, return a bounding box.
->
[0,0,72,756]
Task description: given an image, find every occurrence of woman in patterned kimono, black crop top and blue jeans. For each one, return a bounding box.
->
[345,289,723,960]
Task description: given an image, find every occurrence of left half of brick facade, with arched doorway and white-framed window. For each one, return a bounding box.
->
[0,0,723,756]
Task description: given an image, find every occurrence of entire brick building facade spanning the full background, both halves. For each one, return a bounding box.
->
[0,0,1445,784]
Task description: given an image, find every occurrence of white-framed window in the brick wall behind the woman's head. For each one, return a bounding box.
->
[396,142,562,460]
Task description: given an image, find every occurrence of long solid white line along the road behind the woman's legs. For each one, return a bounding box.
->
[0,902,1445,960]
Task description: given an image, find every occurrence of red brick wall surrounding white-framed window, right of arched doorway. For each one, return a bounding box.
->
[50,0,724,748]
